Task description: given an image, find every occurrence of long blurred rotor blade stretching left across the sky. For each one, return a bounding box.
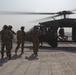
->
[0,11,57,15]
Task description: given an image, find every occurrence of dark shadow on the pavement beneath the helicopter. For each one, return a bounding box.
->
[26,46,76,53]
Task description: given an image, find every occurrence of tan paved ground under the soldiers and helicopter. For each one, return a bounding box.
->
[0,42,76,75]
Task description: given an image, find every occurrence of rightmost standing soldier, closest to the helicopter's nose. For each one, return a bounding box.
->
[32,26,40,56]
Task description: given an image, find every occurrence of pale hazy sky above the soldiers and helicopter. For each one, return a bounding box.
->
[0,0,76,31]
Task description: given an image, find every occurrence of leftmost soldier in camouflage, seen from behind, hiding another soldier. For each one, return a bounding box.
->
[1,25,13,59]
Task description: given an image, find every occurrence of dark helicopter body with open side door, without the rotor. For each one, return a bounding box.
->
[39,18,76,47]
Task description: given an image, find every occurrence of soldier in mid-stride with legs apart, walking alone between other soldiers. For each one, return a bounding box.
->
[15,26,26,54]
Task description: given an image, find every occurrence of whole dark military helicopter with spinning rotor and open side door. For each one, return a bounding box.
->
[0,10,76,47]
